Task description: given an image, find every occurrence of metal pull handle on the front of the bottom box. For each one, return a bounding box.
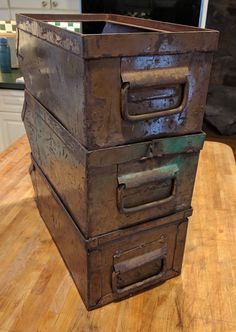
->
[112,245,167,295]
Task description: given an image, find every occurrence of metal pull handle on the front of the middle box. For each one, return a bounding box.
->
[117,164,179,213]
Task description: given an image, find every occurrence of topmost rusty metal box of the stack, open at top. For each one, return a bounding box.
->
[17,14,218,149]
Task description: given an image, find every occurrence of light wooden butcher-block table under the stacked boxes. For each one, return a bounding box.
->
[0,137,236,332]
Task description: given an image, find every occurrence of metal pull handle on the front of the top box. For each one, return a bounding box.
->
[121,67,189,121]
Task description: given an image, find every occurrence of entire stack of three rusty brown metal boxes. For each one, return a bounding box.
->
[17,14,218,309]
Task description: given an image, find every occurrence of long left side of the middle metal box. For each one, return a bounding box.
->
[23,93,87,234]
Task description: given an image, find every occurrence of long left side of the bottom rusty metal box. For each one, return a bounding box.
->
[31,162,88,305]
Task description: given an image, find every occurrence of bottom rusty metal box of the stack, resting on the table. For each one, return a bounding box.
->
[31,158,192,310]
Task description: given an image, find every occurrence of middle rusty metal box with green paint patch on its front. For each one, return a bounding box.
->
[22,92,205,238]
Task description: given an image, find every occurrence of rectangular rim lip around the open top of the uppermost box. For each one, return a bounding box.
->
[16,13,218,59]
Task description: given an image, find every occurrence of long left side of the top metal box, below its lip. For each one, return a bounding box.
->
[18,30,86,145]
